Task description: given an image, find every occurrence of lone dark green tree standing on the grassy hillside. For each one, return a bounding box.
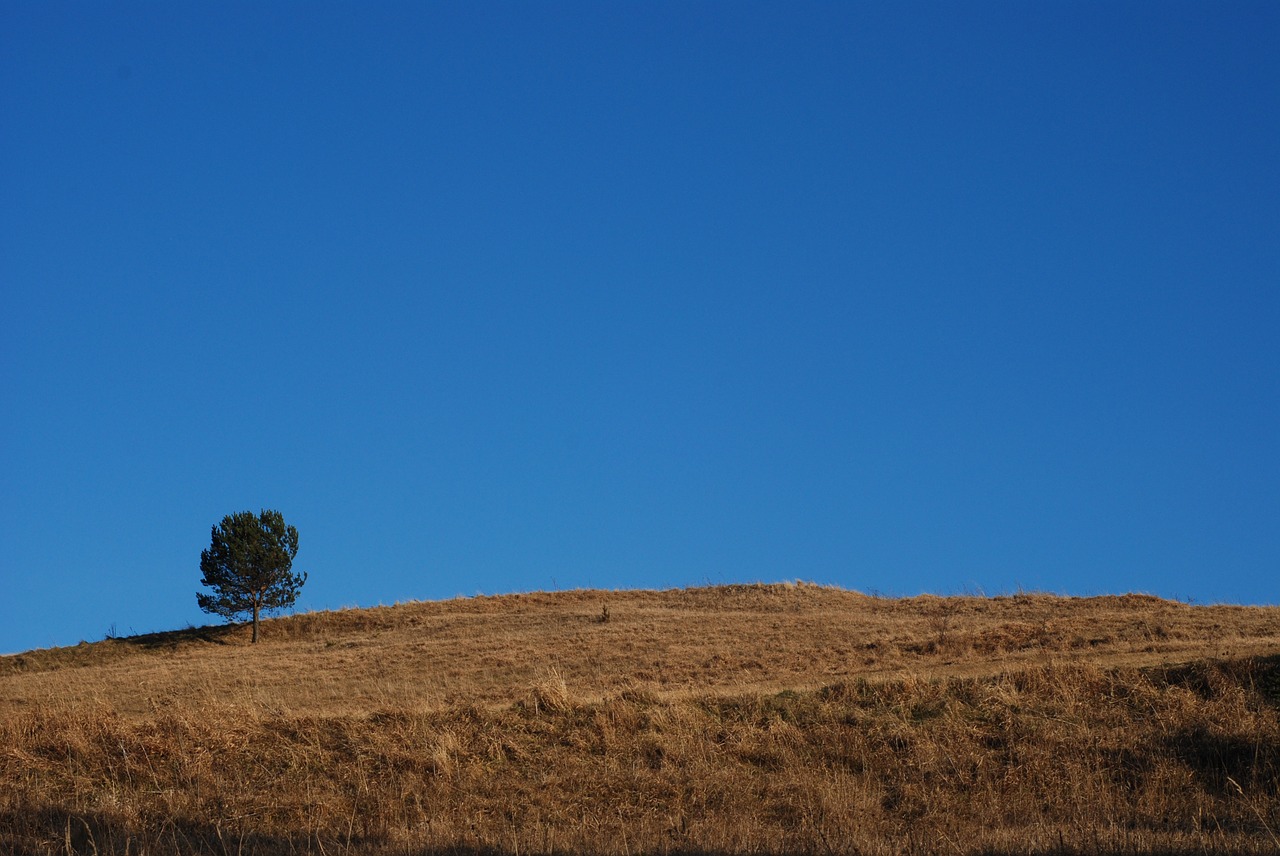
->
[196,511,307,642]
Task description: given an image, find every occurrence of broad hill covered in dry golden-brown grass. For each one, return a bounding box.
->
[0,583,1280,855]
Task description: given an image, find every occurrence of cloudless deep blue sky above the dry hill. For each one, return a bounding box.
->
[0,0,1280,651]
